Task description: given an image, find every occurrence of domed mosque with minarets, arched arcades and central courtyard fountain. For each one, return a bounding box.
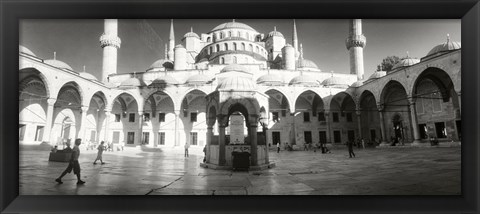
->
[19,19,461,167]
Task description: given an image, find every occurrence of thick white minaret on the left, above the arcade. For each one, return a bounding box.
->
[100,19,121,82]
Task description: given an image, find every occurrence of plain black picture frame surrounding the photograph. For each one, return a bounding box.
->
[0,0,480,214]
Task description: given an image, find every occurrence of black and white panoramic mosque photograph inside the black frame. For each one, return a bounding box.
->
[17,17,462,196]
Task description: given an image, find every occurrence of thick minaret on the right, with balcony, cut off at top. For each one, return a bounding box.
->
[345,19,367,80]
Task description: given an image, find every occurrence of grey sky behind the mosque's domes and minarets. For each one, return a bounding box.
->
[19,19,461,78]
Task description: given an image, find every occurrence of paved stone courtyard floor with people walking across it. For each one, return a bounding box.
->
[19,147,461,195]
